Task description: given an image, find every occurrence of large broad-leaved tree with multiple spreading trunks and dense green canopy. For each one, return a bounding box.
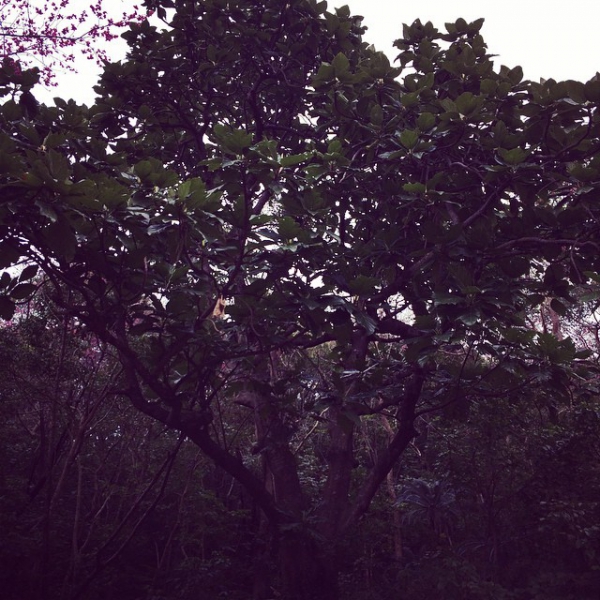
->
[0,0,600,599]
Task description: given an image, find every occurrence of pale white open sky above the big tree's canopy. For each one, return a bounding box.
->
[36,0,600,103]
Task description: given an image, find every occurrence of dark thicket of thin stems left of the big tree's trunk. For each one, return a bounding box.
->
[0,296,253,599]
